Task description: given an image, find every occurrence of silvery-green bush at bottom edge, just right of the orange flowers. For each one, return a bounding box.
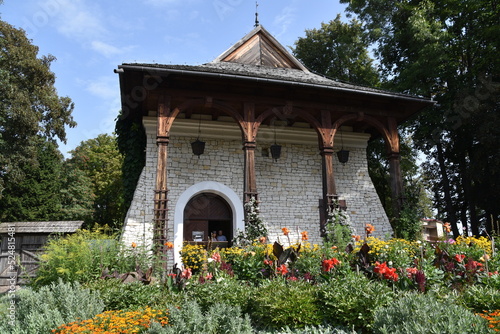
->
[147,301,253,334]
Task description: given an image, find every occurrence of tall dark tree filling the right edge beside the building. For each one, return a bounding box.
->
[341,0,500,235]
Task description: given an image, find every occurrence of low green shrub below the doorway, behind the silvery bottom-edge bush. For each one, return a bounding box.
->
[186,279,255,311]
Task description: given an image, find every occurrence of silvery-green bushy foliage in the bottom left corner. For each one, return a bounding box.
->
[0,281,104,334]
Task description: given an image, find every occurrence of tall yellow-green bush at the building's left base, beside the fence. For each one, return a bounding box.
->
[33,230,139,286]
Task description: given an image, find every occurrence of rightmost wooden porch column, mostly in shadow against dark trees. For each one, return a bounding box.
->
[387,117,404,218]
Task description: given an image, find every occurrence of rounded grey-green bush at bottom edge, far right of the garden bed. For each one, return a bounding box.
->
[373,294,490,334]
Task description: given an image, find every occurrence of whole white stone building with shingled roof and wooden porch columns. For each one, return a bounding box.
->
[115,26,431,264]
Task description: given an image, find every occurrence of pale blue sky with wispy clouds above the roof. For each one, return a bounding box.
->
[0,0,345,156]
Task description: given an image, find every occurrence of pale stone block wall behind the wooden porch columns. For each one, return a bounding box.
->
[122,119,391,263]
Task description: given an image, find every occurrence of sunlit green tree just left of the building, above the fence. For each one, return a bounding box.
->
[67,134,125,227]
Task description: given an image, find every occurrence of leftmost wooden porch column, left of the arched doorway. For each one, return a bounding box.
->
[153,97,170,262]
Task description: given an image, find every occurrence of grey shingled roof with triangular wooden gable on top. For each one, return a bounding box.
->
[119,25,428,100]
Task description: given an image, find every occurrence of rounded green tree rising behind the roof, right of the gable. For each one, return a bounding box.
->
[293,15,380,86]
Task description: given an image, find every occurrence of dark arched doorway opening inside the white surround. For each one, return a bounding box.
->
[183,192,233,245]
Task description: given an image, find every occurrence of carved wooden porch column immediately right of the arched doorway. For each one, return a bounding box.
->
[241,103,258,203]
